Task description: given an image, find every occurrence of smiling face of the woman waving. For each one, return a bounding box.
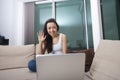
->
[47,22,57,37]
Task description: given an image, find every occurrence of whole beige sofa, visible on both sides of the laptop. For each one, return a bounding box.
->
[0,40,120,80]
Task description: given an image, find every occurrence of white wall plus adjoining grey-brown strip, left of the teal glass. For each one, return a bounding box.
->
[0,0,34,45]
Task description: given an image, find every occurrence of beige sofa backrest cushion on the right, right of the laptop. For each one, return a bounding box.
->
[90,40,120,80]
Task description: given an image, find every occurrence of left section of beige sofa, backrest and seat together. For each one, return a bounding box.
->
[0,44,36,80]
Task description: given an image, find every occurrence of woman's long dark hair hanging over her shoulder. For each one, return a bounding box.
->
[43,18,59,53]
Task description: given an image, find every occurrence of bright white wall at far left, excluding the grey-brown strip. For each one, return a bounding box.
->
[0,0,23,45]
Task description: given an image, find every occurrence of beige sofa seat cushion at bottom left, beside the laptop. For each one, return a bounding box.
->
[0,68,36,80]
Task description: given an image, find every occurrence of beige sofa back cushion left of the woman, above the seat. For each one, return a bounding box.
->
[0,44,35,70]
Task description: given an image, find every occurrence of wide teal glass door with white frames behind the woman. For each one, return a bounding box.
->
[35,0,93,50]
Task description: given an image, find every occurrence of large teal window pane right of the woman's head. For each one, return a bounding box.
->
[56,0,86,49]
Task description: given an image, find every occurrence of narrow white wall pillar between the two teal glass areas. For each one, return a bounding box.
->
[90,0,103,51]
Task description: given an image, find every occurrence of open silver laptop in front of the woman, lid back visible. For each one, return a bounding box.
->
[36,53,85,80]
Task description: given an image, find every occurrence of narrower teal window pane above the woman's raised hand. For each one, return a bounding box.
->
[34,3,52,43]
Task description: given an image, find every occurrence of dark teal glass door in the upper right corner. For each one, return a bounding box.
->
[101,0,120,40]
